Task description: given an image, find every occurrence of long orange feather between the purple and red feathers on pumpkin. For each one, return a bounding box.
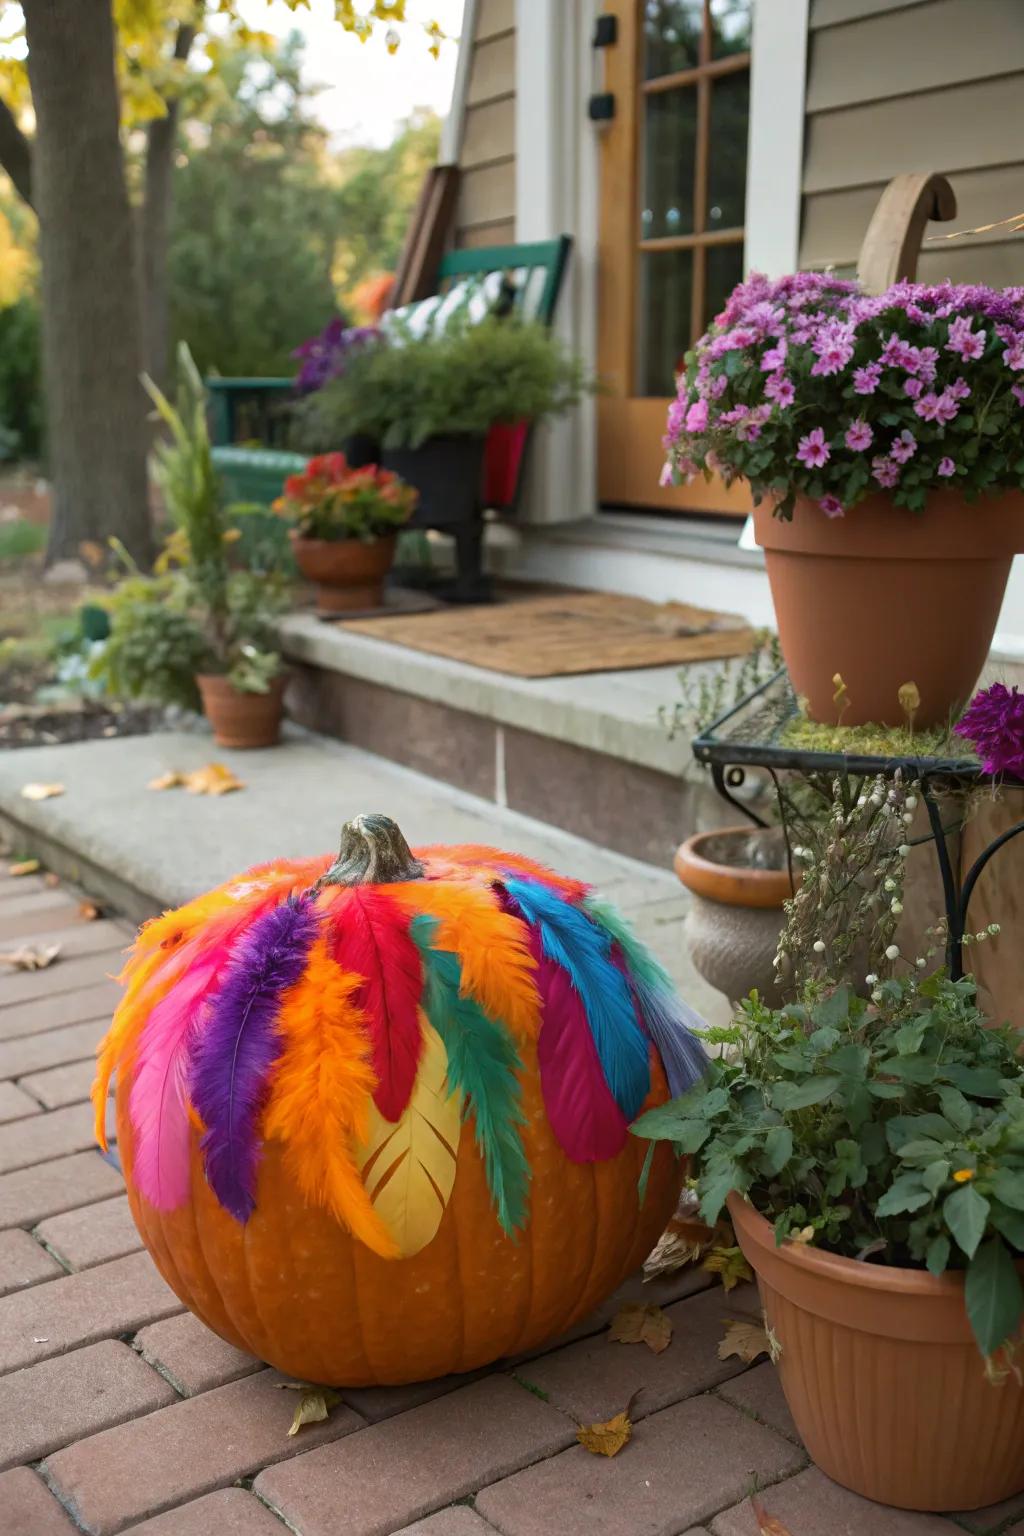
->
[263,935,398,1258]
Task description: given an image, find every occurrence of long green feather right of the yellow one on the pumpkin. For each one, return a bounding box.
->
[410,915,534,1236]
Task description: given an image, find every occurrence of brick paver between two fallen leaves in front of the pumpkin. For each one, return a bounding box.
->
[253,1376,577,1536]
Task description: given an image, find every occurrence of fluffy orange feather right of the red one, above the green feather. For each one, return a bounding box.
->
[388,880,540,1038]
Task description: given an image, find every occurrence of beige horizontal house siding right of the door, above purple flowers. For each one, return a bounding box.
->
[800,0,1024,284]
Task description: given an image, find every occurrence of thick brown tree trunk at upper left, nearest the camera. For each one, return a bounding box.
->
[23,0,154,564]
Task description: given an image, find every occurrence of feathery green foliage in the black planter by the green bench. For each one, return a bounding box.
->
[304,316,593,449]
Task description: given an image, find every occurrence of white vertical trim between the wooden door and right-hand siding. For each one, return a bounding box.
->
[745,0,809,276]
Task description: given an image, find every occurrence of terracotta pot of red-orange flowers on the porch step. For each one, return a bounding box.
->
[273,453,419,613]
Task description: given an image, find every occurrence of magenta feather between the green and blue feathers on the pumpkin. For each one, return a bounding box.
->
[534,945,629,1163]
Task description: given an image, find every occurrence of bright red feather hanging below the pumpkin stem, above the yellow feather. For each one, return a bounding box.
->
[330,889,424,1120]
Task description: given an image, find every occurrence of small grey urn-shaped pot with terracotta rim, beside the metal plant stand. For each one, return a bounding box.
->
[674,826,792,1003]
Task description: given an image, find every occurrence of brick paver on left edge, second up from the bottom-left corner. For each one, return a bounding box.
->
[0,1339,177,1467]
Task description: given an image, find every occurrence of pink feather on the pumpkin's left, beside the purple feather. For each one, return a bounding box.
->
[127,934,228,1210]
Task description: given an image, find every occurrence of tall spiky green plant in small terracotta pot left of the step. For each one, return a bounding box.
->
[92,344,284,748]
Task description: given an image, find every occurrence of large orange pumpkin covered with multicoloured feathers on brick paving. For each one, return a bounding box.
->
[94,816,703,1385]
